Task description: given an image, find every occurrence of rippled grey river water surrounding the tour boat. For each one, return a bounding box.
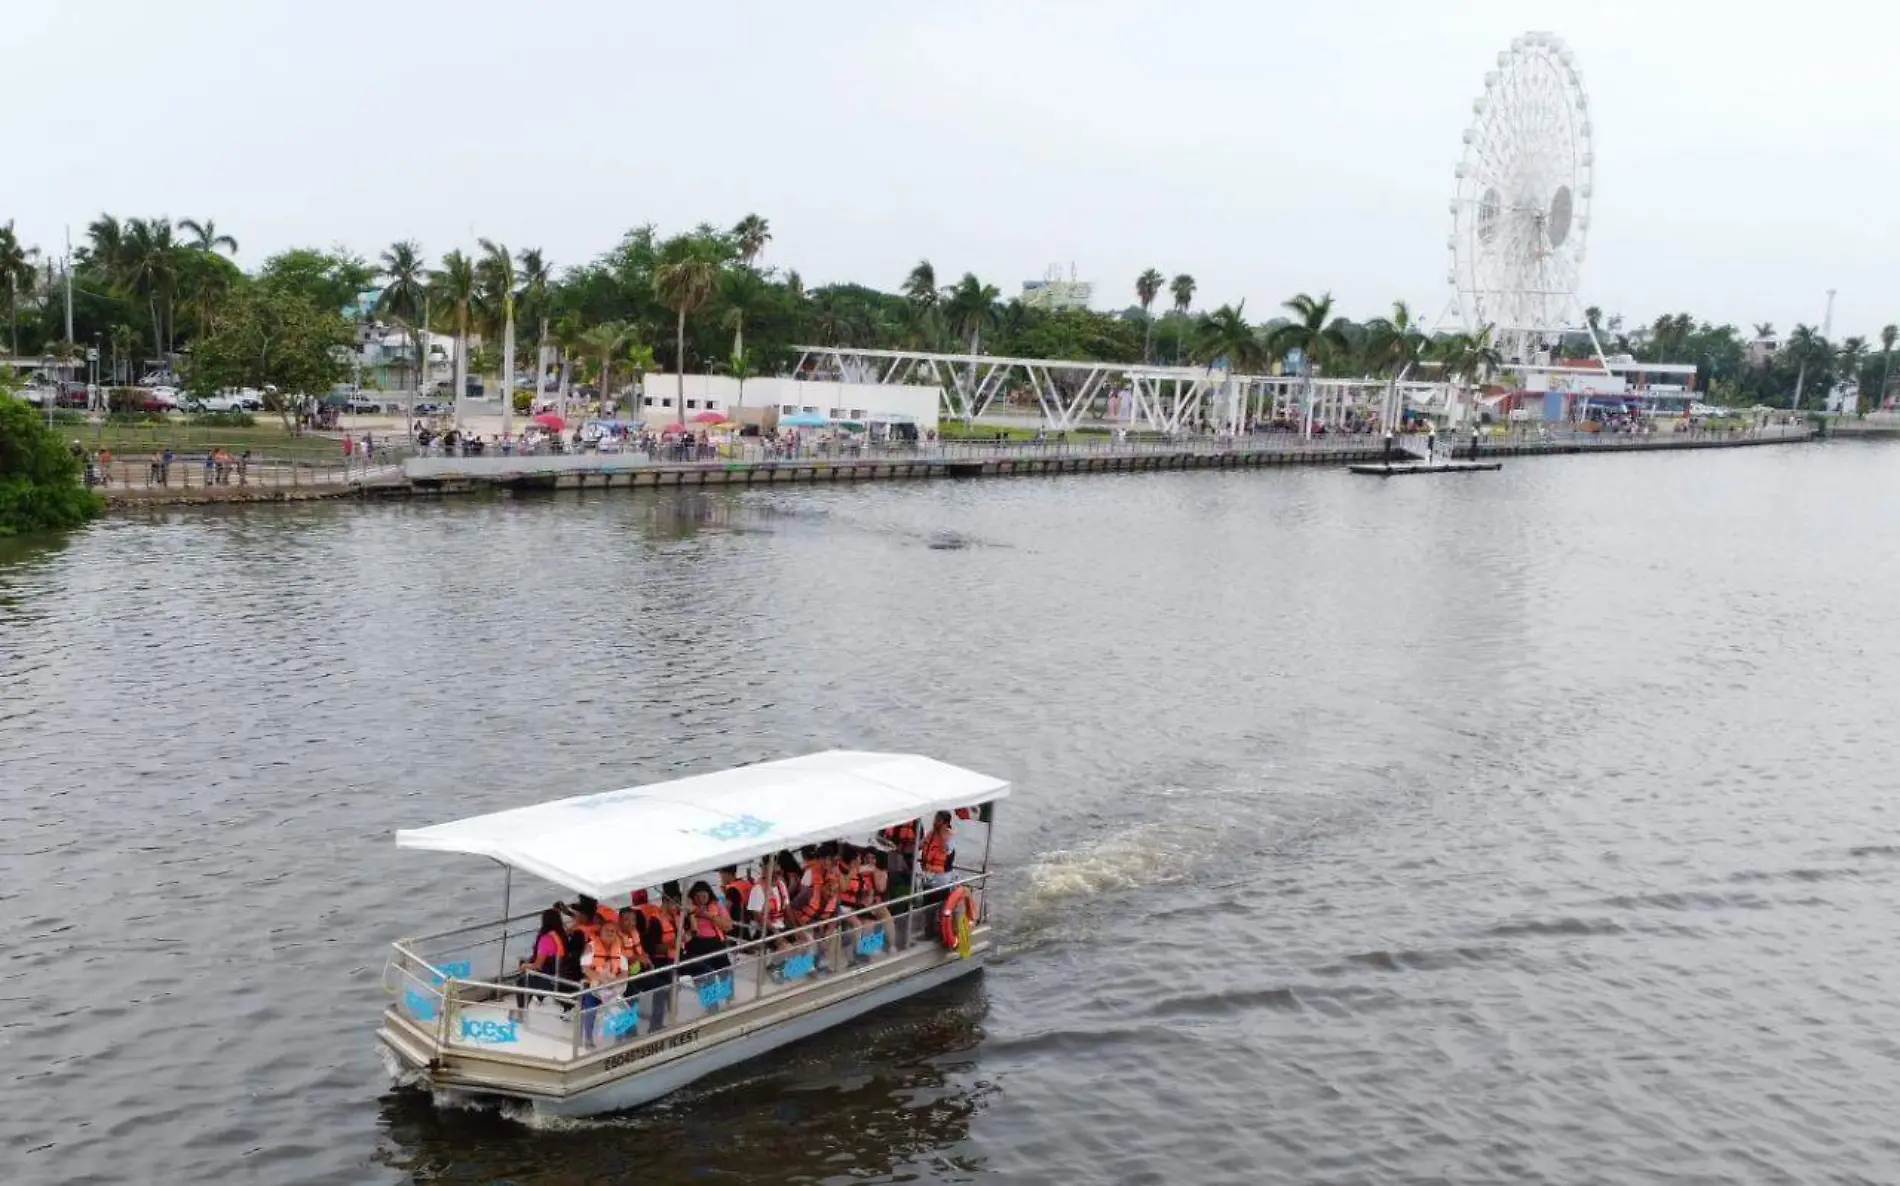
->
[11,445,1900,1184]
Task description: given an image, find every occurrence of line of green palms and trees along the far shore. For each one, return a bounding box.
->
[0,215,1877,407]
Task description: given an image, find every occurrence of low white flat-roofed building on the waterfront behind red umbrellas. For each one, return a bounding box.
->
[635,374,942,431]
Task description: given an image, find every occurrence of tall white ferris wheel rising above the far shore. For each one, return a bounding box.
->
[1450,32,1594,363]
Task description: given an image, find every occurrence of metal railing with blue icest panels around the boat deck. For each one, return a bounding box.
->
[384,872,990,1062]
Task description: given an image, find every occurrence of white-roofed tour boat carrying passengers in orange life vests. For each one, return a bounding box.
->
[376,751,1009,1116]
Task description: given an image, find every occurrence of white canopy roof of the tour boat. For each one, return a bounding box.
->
[395,749,1009,901]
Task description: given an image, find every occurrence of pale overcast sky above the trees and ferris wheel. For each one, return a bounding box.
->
[14,0,1900,336]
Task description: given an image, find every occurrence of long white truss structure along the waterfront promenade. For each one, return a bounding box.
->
[794,346,1444,433]
